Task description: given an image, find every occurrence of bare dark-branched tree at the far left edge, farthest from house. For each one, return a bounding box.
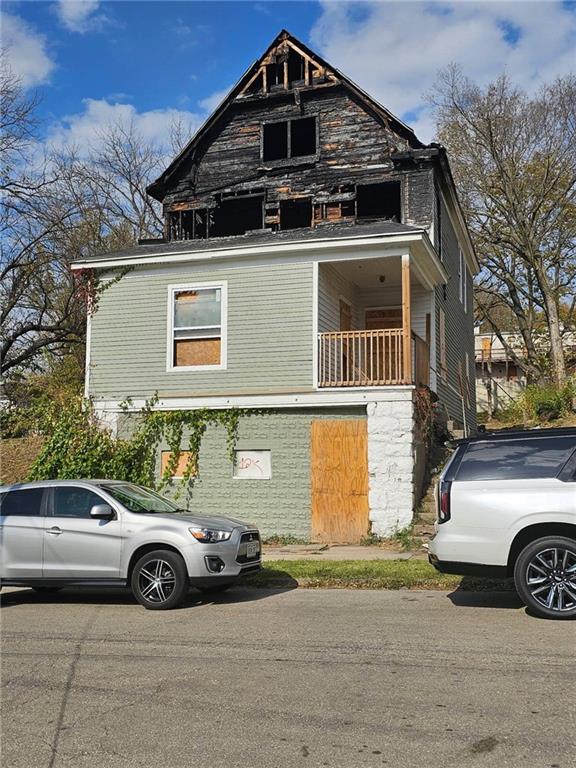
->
[0,62,87,375]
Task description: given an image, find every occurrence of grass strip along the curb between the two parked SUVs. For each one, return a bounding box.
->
[246,560,513,592]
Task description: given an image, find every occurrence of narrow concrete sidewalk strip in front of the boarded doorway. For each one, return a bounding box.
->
[262,544,428,561]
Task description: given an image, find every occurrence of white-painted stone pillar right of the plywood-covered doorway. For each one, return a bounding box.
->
[367,390,414,536]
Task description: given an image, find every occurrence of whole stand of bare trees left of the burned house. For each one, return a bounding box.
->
[0,66,183,377]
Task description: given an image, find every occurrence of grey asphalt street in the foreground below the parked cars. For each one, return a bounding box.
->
[1,588,576,768]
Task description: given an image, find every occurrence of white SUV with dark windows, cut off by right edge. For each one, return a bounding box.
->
[429,428,576,618]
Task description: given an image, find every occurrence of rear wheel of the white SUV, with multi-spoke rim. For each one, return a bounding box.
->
[514,536,576,619]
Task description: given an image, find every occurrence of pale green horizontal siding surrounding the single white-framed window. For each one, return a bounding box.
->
[89,263,313,399]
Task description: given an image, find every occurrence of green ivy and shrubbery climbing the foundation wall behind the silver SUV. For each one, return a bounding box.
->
[28,397,256,492]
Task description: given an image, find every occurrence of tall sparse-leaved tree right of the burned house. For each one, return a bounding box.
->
[430,66,576,385]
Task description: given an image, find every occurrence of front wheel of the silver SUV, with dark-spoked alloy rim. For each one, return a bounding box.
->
[130,549,189,611]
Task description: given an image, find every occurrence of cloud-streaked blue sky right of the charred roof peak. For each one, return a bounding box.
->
[311,1,576,141]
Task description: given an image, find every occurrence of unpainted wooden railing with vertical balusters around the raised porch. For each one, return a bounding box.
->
[318,328,430,387]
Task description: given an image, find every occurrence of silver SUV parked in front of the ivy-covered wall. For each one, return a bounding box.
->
[0,480,261,610]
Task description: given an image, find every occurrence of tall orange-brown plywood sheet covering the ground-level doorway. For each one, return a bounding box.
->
[311,419,368,544]
